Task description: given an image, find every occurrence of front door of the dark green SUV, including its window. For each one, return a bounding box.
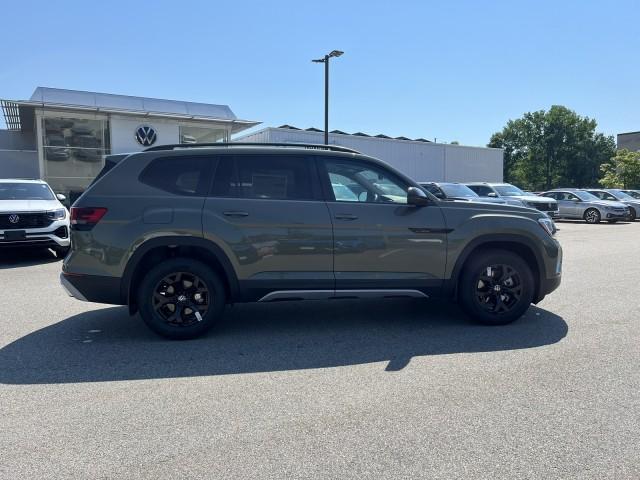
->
[319,158,446,293]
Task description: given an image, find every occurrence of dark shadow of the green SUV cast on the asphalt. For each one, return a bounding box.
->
[0,299,568,384]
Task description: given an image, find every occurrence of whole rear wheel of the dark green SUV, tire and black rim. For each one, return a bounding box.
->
[137,258,226,340]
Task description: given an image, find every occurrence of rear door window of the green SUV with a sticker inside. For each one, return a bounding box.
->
[213,155,316,200]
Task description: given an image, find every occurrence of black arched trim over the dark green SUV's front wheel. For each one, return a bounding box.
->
[445,234,545,303]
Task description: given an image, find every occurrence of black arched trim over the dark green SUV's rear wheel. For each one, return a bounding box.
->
[120,236,240,305]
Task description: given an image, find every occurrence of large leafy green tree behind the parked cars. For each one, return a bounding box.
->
[488,105,615,190]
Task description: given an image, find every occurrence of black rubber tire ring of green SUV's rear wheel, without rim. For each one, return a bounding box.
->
[138,258,226,340]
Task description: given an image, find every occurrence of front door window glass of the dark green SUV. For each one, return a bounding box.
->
[325,160,409,204]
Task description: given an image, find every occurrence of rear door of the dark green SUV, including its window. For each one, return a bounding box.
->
[203,153,334,300]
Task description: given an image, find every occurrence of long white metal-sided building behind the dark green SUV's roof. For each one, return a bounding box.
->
[234,125,503,182]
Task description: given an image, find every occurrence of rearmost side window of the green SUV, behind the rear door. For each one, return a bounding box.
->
[140,157,214,197]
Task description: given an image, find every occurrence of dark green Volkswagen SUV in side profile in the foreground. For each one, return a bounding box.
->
[61,143,562,338]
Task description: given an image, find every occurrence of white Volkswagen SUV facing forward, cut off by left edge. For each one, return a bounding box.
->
[0,179,71,257]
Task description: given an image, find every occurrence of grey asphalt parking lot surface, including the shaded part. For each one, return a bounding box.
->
[0,222,640,479]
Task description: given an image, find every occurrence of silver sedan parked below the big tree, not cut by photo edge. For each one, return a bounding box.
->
[540,188,629,223]
